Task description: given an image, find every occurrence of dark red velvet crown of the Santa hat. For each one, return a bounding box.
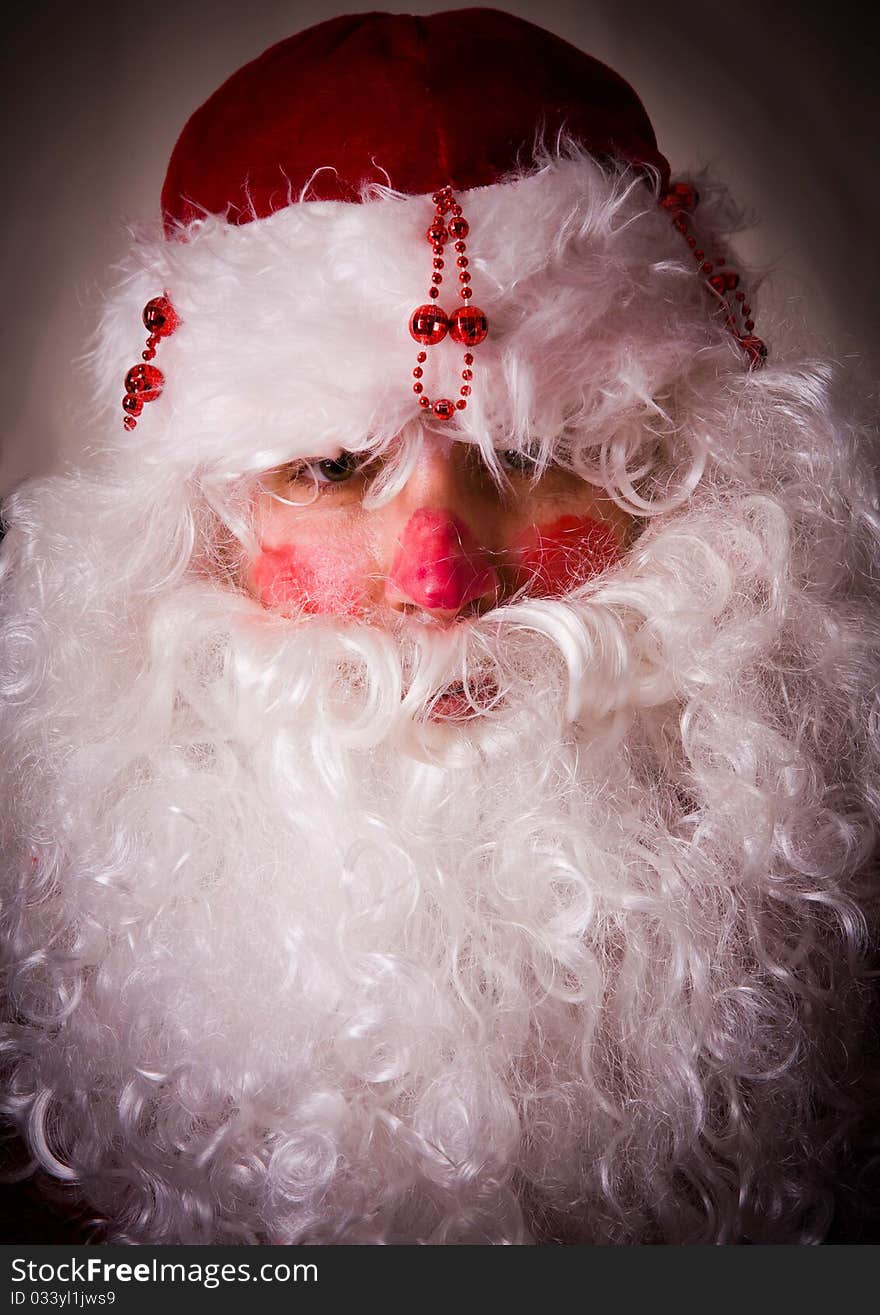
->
[162,9,668,233]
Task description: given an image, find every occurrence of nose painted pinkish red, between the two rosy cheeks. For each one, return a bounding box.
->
[388,508,499,611]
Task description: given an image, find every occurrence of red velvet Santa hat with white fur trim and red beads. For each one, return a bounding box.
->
[112,9,763,469]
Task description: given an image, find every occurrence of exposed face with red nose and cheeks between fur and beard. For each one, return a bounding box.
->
[245,431,631,623]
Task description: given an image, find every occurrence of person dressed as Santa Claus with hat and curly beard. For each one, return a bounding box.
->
[0,9,880,1244]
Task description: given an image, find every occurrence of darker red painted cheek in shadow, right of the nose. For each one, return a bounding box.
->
[513,515,622,598]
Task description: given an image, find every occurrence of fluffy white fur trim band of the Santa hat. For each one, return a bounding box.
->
[109,160,706,469]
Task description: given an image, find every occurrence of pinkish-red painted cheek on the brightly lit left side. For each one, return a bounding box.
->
[251,543,368,615]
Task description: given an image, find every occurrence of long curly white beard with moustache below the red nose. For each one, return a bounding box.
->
[3,465,873,1243]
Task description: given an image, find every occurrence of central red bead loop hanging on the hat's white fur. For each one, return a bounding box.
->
[409,187,489,421]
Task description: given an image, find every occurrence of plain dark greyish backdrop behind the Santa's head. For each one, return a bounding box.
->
[0,0,880,492]
